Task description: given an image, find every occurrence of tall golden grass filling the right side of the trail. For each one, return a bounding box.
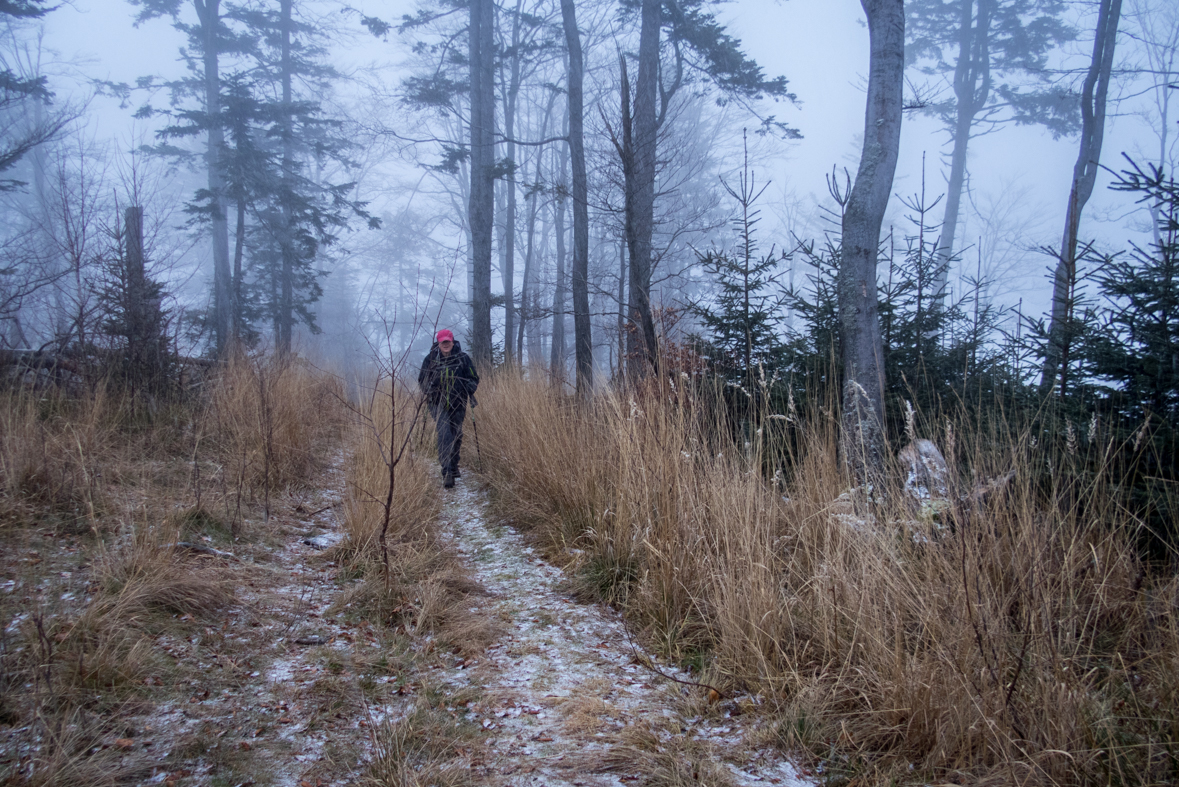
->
[477,376,1179,785]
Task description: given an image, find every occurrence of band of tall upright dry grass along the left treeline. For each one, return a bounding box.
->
[0,357,347,533]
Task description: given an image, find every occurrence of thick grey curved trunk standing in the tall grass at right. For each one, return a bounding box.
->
[837,0,904,483]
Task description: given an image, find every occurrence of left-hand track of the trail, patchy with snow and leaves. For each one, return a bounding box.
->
[132,456,388,787]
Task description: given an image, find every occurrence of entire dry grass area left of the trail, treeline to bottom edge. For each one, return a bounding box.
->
[0,361,345,786]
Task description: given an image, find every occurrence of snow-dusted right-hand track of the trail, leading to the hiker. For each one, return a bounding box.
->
[443,480,810,787]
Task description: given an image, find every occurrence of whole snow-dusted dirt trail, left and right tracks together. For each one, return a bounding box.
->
[57,458,809,787]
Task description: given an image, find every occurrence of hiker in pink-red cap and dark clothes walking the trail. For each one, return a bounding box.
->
[417,329,479,489]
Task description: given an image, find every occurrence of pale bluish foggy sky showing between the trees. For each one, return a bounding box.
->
[6,0,1174,381]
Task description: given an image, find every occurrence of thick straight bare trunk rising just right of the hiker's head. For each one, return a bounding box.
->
[467,0,495,369]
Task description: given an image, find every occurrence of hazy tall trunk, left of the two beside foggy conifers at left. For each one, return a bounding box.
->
[193,0,232,356]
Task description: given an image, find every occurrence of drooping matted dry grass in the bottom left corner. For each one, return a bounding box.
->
[0,513,232,787]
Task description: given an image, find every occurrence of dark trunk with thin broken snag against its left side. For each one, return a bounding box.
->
[624,0,660,381]
